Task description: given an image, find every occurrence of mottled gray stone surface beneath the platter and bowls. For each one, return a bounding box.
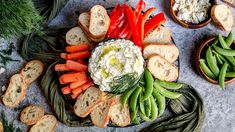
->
[0,0,235,132]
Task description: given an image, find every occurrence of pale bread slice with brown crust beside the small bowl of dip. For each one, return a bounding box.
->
[211,5,234,31]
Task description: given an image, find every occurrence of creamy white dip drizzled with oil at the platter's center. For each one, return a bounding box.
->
[88,39,144,91]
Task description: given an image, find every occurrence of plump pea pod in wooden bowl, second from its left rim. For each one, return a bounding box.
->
[206,47,219,77]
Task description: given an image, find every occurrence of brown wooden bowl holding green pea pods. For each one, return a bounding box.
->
[196,36,235,84]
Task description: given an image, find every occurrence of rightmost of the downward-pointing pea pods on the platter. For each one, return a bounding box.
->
[152,88,166,116]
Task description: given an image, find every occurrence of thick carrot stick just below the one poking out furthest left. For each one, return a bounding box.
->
[59,72,87,84]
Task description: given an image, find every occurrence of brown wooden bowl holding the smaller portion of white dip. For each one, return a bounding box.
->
[170,0,217,29]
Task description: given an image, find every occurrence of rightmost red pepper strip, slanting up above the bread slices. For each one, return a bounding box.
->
[144,12,166,36]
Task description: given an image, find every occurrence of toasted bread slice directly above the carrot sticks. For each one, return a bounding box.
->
[66,26,90,45]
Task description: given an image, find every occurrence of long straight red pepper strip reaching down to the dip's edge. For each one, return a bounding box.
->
[125,6,142,50]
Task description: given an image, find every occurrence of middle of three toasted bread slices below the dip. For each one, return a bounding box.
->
[90,97,115,128]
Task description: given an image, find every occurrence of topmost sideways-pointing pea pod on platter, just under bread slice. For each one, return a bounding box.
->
[157,80,183,90]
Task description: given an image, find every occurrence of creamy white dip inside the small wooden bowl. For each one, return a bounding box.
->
[173,0,211,24]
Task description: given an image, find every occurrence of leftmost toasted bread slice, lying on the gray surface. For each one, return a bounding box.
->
[2,74,27,108]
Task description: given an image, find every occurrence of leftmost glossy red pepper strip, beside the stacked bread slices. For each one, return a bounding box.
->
[107,8,125,38]
